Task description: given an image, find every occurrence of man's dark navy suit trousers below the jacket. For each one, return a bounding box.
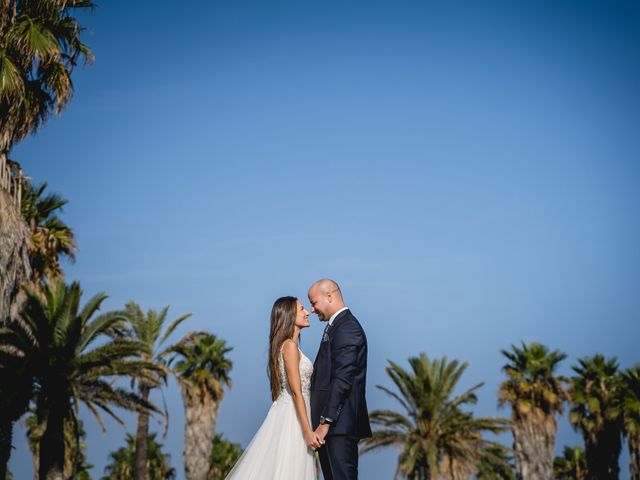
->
[318,435,360,480]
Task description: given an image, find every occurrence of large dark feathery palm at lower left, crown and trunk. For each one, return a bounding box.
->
[14,282,157,480]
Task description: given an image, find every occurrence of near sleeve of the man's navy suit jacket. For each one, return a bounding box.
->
[324,322,363,421]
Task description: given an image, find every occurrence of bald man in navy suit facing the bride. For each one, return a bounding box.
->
[309,279,371,480]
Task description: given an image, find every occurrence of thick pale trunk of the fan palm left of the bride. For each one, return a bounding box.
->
[179,380,220,480]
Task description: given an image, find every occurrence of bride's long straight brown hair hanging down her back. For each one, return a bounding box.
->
[267,297,298,400]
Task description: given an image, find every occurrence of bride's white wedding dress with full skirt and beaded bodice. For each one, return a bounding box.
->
[226,349,316,480]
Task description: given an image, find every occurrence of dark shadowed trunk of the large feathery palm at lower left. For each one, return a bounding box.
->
[38,397,69,480]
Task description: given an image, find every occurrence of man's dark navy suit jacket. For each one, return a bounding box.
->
[311,310,371,438]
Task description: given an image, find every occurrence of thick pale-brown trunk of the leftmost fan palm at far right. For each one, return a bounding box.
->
[512,409,558,480]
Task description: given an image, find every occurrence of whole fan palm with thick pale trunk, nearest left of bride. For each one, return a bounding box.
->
[170,332,233,480]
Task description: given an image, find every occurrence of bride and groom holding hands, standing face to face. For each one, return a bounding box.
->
[227,279,371,480]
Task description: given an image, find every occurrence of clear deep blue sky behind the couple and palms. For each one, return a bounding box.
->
[6,0,640,480]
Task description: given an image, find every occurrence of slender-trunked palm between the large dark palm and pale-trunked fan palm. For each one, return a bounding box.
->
[122,301,191,480]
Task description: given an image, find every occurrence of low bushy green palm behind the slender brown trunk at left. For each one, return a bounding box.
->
[101,433,176,480]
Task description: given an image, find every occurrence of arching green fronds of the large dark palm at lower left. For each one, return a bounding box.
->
[22,282,160,420]
